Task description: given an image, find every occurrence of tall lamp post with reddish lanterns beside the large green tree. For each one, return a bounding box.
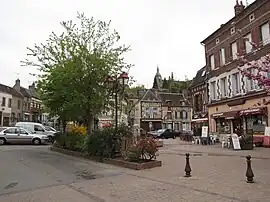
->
[108,72,129,158]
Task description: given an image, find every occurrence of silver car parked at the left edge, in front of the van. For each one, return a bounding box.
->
[0,127,48,145]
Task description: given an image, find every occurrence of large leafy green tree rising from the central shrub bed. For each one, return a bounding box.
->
[23,14,131,134]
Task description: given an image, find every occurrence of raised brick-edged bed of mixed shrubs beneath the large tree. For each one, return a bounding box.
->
[51,126,161,170]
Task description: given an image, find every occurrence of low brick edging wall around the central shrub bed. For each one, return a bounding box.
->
[50,146,162,170]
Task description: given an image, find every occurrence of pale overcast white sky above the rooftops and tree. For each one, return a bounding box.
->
[0,0,254,87]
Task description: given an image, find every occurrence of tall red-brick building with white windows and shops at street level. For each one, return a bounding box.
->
[202,0,270,136]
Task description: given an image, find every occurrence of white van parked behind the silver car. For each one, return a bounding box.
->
[15,122,56,141]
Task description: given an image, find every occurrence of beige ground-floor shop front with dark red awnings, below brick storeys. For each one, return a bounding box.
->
[208,97,270,137]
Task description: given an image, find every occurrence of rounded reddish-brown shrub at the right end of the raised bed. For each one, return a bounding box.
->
[127,137,158,161]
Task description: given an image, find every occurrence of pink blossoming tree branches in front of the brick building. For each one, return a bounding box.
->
[238,39,270,92]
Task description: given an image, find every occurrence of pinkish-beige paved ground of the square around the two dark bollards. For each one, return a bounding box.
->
[0,142,270,202]
